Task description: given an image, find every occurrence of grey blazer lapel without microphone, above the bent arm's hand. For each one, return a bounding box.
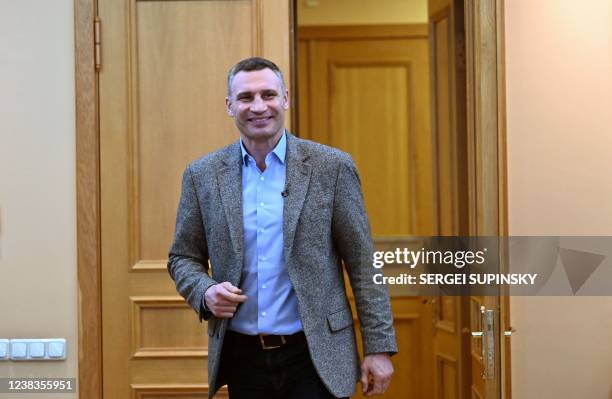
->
[217,142,244,285]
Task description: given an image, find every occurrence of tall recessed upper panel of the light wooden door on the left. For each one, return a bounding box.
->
[135,1,253,268]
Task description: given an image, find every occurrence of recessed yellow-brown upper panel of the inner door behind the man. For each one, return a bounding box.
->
[326,61,416,235]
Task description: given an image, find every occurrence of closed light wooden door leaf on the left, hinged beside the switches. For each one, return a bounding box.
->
[99,0,290,399]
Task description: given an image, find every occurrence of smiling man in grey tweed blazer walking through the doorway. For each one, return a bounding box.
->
[168,58,397,399]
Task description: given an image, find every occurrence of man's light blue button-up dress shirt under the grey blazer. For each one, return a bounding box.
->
[229,133,302,335]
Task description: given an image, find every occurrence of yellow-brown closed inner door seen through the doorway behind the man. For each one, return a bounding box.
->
[298,25,434,399]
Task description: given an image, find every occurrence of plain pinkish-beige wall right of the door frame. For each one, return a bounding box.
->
[505,0,612,399]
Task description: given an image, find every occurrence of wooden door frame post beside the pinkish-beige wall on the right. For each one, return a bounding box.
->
[463,0,512,399]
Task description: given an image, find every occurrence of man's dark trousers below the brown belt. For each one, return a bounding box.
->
[221,331,346,399]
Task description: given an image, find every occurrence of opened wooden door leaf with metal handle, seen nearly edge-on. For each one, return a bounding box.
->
[428,0,500,399]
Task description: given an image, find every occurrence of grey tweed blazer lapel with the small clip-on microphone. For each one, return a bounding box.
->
[283,133,311,259]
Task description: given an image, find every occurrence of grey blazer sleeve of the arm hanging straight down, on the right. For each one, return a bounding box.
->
[332,155,397,355]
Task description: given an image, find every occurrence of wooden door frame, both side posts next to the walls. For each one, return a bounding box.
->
[74,0,511,399]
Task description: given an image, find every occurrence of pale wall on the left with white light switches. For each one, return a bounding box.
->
[0,0,78,399]
